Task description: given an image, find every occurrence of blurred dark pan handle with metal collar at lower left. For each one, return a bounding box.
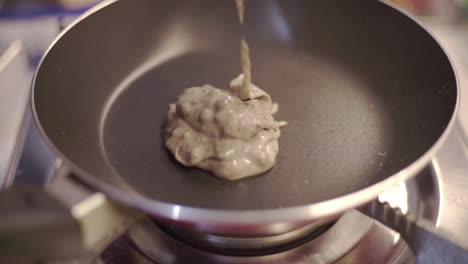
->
[0,163,143,263]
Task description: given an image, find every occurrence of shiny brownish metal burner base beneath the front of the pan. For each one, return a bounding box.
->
[129,210,414,264]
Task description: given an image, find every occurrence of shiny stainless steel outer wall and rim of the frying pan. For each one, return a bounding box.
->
[31,0,460,234]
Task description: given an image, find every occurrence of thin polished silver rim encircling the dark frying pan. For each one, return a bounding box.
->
[30,0,461,226]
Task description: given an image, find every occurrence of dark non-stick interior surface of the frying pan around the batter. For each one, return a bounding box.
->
[34,0,457,209]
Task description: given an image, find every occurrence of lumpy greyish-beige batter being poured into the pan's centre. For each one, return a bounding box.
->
[165,0,286,180]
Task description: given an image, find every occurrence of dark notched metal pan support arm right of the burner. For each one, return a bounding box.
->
[361,199,468,264]
